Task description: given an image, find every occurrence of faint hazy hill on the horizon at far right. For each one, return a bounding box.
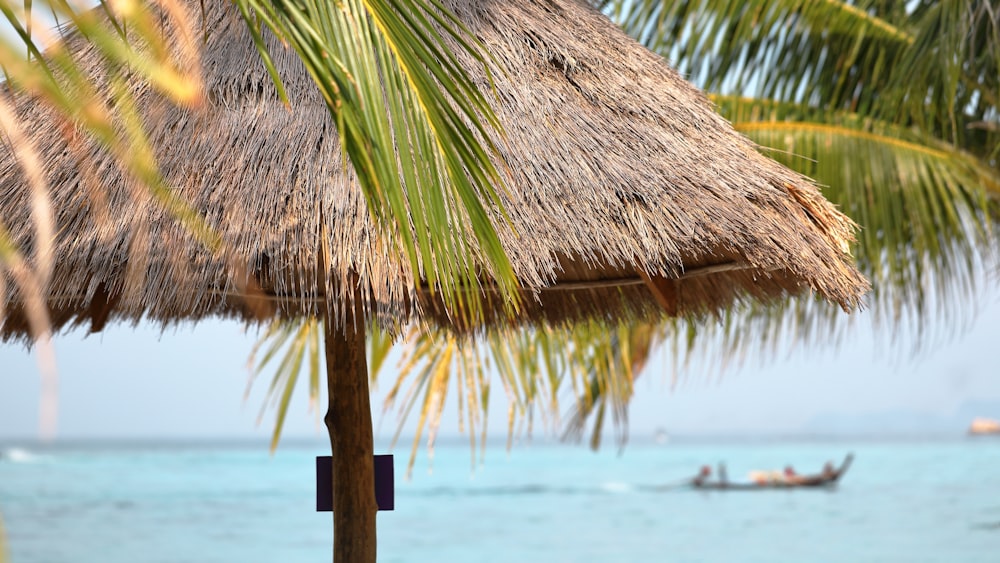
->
[803,400,1000,435]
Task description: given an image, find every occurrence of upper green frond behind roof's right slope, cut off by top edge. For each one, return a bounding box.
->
[603,0,914,110]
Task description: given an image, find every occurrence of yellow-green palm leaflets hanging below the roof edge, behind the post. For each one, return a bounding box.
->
[248,320,652,474]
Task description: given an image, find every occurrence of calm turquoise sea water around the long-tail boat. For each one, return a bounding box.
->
[0,439,1000,563]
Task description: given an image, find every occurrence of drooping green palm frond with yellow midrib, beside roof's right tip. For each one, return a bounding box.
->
[715,96,1000,332]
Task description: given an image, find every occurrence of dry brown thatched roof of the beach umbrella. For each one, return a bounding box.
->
[0,0,868,337]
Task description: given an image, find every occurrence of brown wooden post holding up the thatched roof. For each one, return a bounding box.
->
[323,294,378,563]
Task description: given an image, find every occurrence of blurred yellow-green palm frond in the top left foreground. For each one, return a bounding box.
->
[0,0,219,248]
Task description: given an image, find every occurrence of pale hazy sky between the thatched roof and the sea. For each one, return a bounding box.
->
[0,286,1000,446]
